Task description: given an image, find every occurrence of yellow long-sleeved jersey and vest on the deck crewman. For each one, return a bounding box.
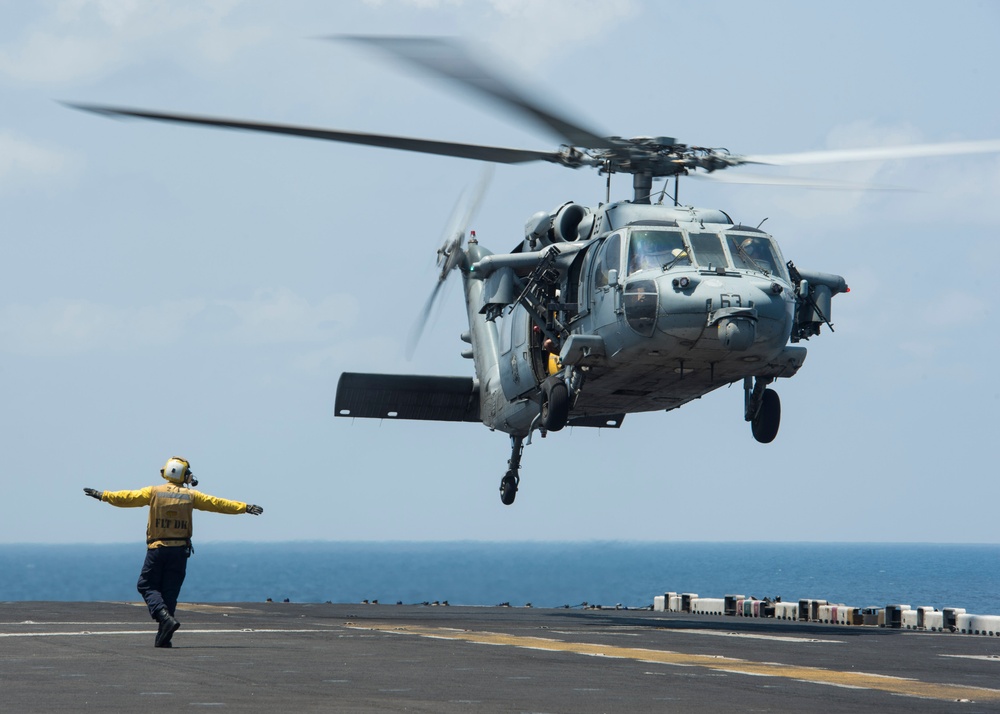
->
[101,483,247,548]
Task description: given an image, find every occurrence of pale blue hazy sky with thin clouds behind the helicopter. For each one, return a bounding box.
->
[0,0,1000,547]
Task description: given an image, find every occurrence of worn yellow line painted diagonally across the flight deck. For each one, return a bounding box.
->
[349,623,1000,702]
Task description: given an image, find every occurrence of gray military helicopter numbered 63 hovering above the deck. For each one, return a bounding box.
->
[71,37,1000,505]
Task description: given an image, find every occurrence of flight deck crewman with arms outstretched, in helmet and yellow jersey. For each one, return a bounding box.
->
[83,456,264,647]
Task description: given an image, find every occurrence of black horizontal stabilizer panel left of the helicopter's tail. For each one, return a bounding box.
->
[334,372,480,422]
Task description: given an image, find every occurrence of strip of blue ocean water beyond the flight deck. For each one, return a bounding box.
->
[0,542,1000,614]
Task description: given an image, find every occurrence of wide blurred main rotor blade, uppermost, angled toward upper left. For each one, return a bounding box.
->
[338,35,615,149]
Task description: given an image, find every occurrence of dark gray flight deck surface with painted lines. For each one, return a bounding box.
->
[0,602,1000,713]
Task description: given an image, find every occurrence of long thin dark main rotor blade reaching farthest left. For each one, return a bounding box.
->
[64,102,561,164]
